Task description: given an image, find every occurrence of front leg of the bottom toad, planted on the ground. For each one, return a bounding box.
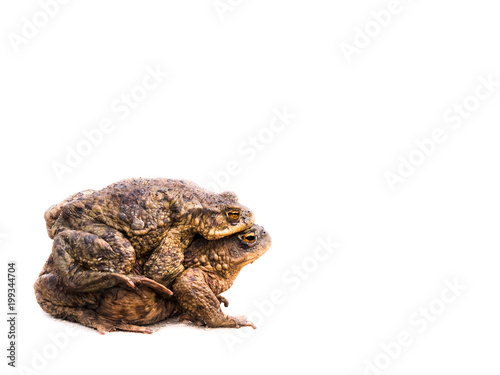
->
[172,268,256,329]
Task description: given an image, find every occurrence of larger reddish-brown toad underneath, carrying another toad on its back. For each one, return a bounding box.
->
[34,225,271,333]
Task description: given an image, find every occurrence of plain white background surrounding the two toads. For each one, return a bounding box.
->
[0,0,500,375]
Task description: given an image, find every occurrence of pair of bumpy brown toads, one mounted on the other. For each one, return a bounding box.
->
[35,179,271,333]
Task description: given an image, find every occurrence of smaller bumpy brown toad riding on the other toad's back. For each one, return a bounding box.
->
[45,178,254,292]
